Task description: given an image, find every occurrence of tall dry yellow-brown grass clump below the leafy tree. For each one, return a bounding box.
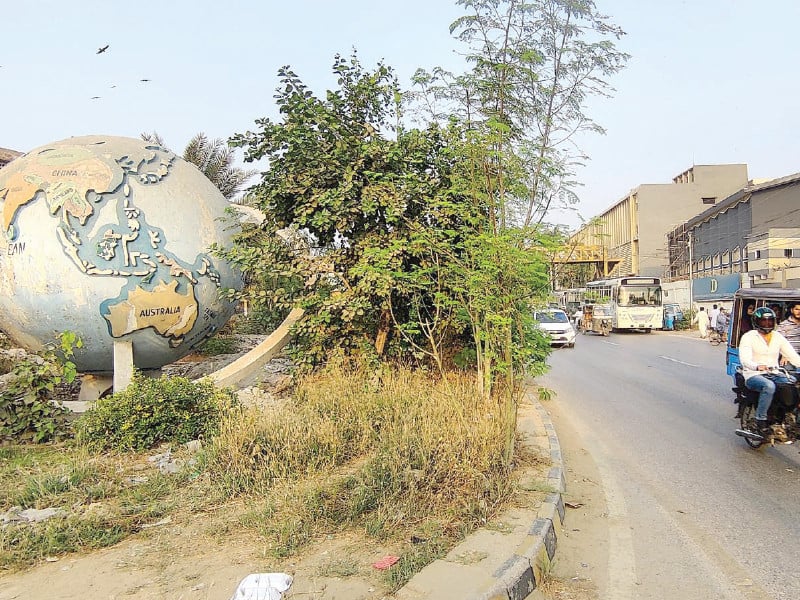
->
[206,365,512,568]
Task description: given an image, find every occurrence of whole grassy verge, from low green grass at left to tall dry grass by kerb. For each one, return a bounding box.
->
[0,365,552,590]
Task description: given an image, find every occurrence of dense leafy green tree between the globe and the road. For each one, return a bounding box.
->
[226,56,547,394]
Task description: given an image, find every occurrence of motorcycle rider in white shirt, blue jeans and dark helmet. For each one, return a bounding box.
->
[739,306,800,437]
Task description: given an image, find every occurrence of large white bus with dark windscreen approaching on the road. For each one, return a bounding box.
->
[586,276,664,333]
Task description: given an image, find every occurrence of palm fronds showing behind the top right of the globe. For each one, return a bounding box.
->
[141,131,257,200]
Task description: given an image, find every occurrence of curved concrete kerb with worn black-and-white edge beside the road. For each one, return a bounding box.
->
[395,395,566,600]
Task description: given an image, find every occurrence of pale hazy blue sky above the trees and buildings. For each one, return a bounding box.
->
[0,0,800,230]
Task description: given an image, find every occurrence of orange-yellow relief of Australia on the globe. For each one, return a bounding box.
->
[103,281,198,345]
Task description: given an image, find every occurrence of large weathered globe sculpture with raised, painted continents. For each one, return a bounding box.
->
[0,136,241,374]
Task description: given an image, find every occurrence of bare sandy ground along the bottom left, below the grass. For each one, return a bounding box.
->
[0,515,406,600]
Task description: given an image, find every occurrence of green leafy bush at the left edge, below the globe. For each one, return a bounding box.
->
[0,331,83,444]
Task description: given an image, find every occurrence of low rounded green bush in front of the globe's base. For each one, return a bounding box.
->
[75,372,236,451]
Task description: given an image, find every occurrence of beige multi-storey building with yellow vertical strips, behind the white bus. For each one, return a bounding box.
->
[572,164,748,277]
